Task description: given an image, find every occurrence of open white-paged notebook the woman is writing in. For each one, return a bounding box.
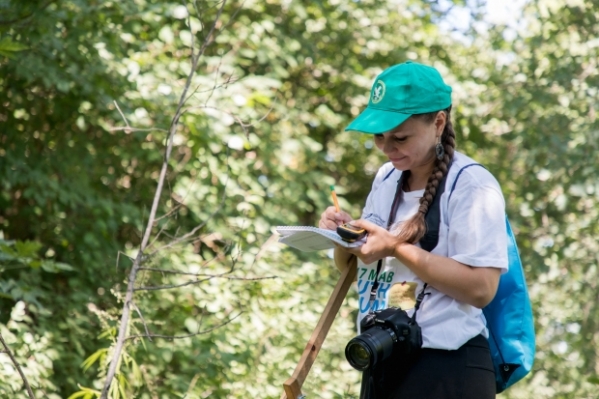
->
[276,226,366,252]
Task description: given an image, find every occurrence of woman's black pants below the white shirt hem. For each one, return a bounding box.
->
[362,335,495,399]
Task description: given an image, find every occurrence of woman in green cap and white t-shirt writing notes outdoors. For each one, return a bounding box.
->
[319,62,508,399]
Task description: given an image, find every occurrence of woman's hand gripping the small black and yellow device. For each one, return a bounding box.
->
[347,219,399,264]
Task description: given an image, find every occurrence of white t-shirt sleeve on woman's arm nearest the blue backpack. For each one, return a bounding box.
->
[448,168,508,273]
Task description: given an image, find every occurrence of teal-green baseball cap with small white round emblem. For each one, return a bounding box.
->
[345,61,451,134]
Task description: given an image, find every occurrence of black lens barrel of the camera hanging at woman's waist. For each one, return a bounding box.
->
[345,327,397,371]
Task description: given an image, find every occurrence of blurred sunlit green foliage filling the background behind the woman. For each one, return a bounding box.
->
[0,0,599,399]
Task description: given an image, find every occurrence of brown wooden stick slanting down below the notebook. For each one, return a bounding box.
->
[281,259,357,399]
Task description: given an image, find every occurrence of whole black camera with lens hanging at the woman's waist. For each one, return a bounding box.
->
[345,308,422,371]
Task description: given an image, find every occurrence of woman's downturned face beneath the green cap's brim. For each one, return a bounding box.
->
[374,112,445,172]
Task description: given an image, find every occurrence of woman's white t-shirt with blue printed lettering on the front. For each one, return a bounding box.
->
[357,152,508,349]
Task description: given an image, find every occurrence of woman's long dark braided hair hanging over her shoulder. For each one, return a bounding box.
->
[398,106,455,244]
